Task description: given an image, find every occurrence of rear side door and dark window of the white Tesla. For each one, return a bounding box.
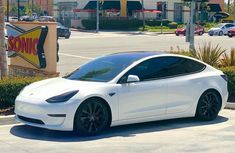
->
[166,57,205,114]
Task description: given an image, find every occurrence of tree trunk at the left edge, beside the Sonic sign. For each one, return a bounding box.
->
[0,0,7,79]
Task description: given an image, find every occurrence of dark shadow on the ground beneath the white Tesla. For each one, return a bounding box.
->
[10,116,228,142]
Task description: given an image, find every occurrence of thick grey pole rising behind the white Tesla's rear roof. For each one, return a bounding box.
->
[189,0,196,52]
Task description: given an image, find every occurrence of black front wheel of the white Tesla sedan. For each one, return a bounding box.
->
[74,98,111,136]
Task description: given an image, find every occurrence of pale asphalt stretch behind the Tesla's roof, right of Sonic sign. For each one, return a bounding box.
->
[58,31,235,76]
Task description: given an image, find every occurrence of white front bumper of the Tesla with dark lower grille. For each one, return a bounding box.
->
[15,97,78,131]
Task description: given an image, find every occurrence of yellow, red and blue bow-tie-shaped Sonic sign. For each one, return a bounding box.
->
[6,24,48,69]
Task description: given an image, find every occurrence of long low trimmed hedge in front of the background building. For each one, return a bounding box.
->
[82,19,172,30]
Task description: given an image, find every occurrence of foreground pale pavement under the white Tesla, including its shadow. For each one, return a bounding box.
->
[0,110,235,153]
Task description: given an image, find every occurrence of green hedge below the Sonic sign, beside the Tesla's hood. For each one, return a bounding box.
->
[0,77,43,108]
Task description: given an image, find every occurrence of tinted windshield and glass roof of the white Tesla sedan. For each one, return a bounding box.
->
[65,53,158,82]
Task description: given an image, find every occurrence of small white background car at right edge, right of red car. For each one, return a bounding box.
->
[208,23,235,36]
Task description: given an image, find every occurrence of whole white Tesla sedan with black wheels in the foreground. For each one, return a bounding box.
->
[15,52,228,135]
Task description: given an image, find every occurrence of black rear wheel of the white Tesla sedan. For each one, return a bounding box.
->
[195,90,222,121]
